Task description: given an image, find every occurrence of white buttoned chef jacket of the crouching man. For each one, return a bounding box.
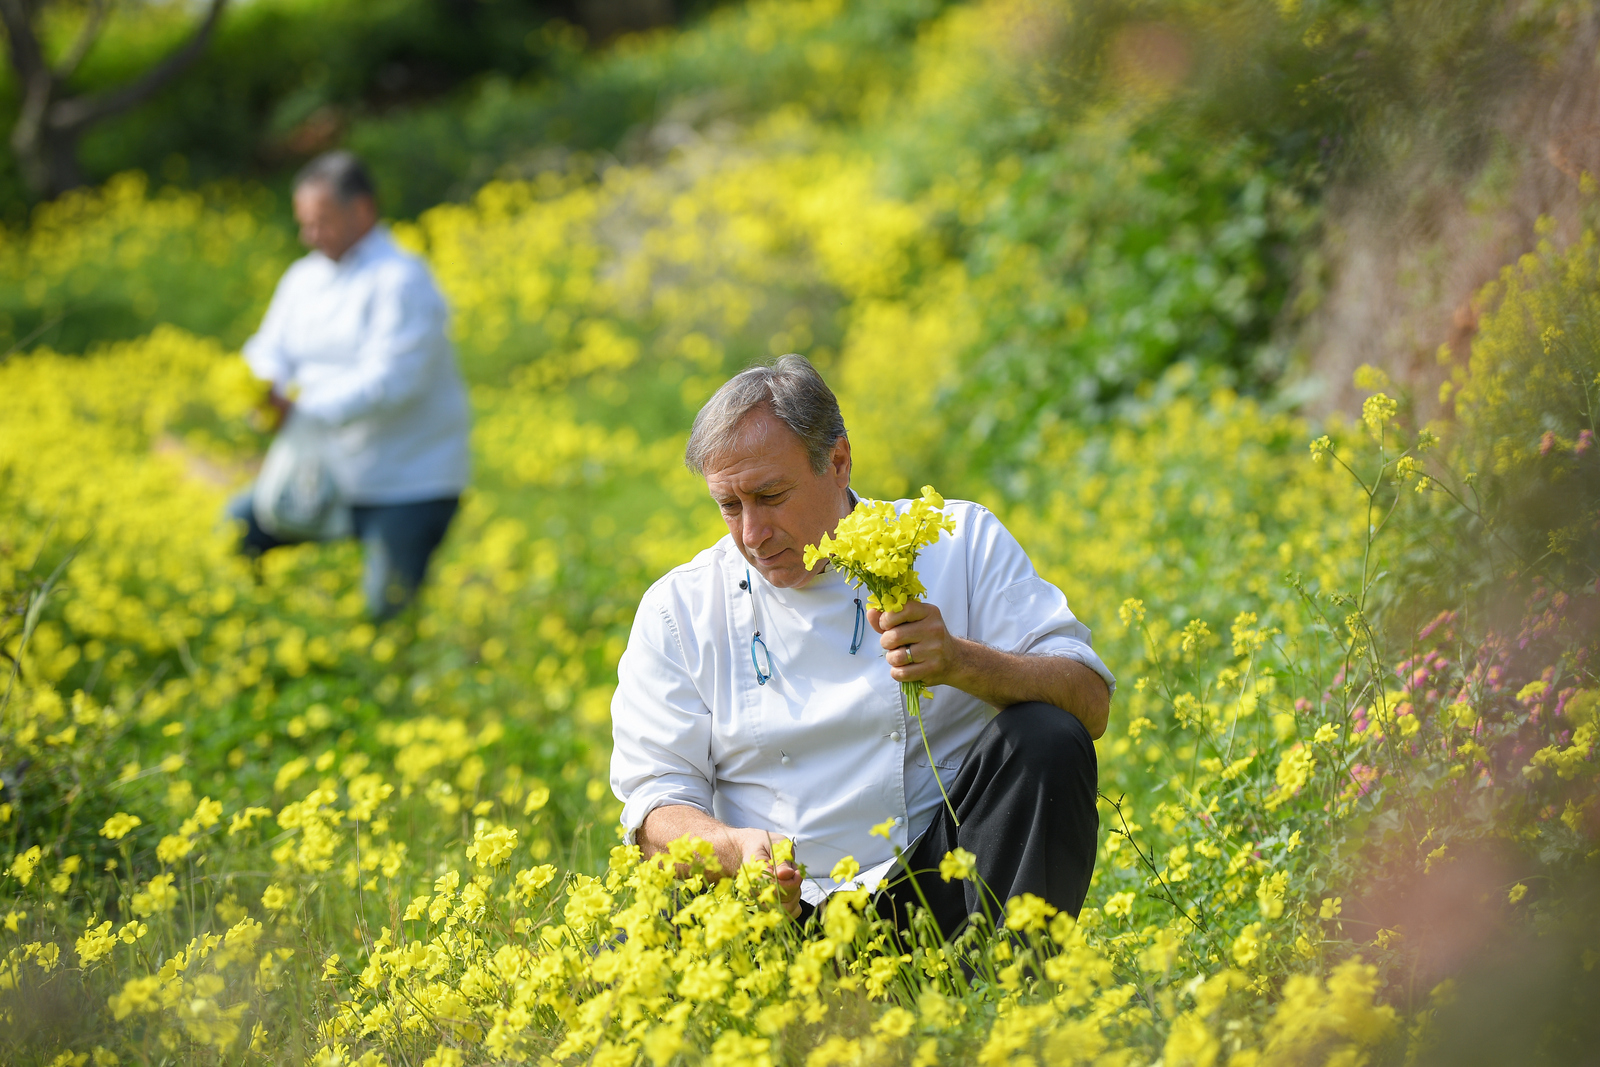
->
[611,501,1115,904]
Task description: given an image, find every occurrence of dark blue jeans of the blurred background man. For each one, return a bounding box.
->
[226,486,461,621]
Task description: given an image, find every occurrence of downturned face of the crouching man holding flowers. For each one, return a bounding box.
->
[706,408,850,589]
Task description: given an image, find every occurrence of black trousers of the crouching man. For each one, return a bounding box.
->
[877,702,1099,939]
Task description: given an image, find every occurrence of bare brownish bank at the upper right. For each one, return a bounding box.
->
[1301,14,1600,421]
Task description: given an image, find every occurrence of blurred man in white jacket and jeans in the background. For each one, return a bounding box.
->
[227,152,469,619]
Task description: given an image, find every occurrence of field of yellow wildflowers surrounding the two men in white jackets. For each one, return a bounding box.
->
[0,0,1600,1067]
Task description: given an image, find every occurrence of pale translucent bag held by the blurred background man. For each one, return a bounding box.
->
[251,411,354,541]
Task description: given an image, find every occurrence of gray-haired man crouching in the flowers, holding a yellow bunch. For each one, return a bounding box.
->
[611,355,1115,937]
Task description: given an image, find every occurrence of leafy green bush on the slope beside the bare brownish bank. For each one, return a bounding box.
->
[947,120,1317,494]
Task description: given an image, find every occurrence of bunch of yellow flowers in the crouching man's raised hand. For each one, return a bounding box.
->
[805,485,955,611]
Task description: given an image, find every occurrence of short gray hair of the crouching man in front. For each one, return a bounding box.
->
[683,354,846,477]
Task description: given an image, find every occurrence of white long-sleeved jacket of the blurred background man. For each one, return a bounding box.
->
[245,226,470,504]
